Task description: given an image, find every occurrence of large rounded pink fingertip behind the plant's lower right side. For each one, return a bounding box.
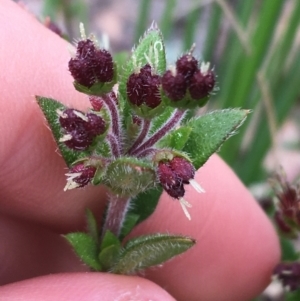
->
[132,156,280,301]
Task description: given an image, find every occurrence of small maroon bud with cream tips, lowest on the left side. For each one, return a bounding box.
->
[65,163,96,190]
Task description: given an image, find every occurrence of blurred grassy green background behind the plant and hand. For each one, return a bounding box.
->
[15,0,300,300]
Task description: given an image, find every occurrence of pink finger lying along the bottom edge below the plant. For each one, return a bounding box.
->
[0,273,175,301]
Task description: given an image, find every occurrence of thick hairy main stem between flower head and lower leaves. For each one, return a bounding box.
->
[102,194,130,236]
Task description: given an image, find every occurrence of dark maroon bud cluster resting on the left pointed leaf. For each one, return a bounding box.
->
[58,109,106,151]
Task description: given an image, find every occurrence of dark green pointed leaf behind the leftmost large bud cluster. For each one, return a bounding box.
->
[36,96,86,166]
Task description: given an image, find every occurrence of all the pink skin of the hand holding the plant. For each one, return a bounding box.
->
[0,0,280,301]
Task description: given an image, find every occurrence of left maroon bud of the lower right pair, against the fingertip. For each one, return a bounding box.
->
[157,161,185,199]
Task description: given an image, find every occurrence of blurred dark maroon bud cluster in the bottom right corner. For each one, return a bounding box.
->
[273,262,300,291]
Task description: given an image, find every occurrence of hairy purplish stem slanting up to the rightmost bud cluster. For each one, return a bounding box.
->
[131,109,185,156]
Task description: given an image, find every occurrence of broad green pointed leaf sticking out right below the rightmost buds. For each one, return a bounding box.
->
[183,109,249,168]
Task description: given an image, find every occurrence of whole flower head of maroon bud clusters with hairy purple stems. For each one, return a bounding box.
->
[59,28,209,215]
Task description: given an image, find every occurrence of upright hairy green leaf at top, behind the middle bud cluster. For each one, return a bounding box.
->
[119,23,166,100]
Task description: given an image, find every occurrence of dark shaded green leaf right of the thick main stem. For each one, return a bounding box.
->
[127,187,162,224]
